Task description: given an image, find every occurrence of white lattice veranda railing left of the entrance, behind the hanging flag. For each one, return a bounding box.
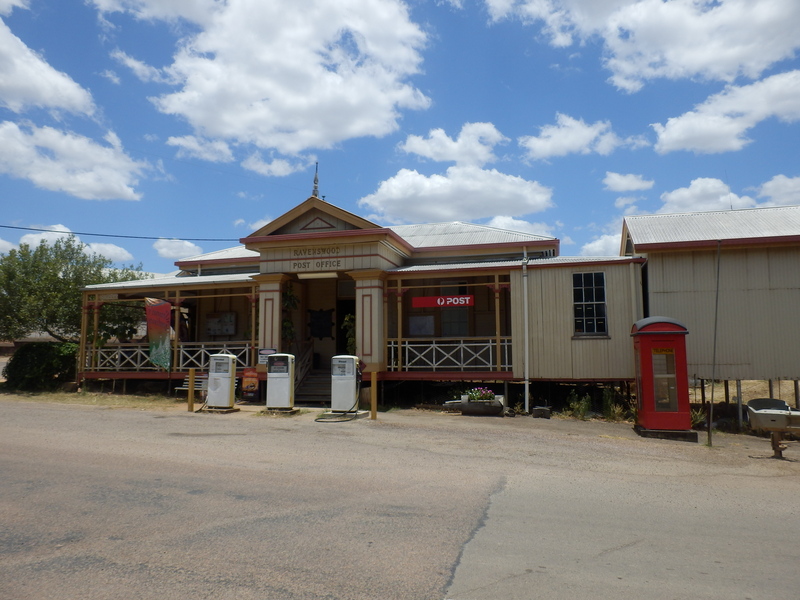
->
[85,342,250,371]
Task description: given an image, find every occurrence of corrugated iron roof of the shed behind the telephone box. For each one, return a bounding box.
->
[625,206,800,249]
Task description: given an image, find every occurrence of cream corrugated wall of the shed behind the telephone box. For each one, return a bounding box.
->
[648,247,800,380]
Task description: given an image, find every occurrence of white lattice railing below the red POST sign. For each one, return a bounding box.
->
[388,337,512,371]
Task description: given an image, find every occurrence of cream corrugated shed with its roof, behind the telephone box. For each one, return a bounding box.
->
[622,206,800,380]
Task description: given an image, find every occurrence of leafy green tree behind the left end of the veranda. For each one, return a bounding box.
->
[0,236,146,342]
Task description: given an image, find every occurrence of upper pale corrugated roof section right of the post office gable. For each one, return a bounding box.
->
[388,221,556,248]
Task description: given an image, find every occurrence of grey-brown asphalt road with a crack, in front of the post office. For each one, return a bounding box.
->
[0,399,800,600]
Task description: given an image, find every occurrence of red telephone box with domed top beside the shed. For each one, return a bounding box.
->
[631,317,696,437]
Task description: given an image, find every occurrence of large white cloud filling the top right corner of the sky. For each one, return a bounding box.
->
[485,0,800,92]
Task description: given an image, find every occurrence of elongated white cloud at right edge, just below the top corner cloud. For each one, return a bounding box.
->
[652,71,800,154]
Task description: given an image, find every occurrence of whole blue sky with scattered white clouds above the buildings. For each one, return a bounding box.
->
[0,0,800,272]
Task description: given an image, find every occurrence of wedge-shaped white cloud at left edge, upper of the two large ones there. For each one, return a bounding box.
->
[0,19,95,115]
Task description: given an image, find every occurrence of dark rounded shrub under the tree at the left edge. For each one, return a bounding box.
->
[3,342,78,392]
